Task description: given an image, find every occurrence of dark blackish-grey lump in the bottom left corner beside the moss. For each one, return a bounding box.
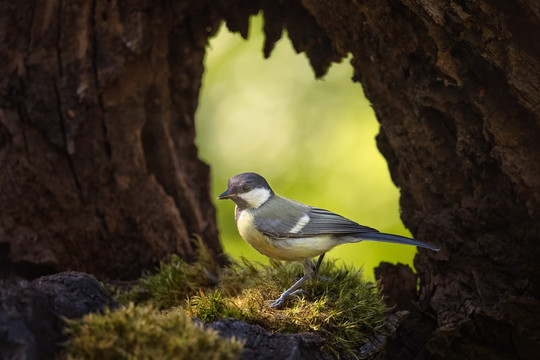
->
[0,271,118,360]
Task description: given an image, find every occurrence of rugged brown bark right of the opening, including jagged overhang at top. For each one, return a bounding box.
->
[215,0,540,359]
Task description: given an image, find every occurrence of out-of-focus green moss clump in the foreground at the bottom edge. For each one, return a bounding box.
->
[64,304,242,360]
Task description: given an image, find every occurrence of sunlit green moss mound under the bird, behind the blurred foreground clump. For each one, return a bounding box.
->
[103,246,388,355]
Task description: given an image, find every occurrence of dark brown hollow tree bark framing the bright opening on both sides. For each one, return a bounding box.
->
[0,0,540,359]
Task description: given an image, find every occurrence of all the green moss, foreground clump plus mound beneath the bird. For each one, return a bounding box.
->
[61,240,388,359]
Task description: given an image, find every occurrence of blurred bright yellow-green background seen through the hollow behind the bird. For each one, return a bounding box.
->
[195,15,416,279]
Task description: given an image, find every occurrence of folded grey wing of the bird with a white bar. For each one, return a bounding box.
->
[255,198,377,239]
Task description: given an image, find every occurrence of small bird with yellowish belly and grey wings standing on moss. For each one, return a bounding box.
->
[218,172,439,308]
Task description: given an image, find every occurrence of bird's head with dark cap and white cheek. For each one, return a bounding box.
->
[218,173,274,209]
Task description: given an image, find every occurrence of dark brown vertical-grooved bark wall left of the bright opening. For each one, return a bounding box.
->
[0,0,221,278]
